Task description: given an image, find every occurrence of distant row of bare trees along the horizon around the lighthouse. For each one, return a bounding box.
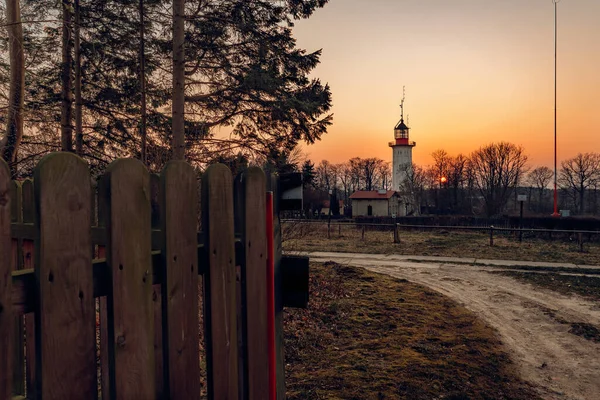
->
[295,142,600,217]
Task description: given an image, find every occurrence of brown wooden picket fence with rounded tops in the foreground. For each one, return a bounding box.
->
[0,153,282,400]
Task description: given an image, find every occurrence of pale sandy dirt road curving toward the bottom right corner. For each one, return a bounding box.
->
[310,253,600,400]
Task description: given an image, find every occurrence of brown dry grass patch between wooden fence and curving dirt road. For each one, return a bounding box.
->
[284,263,537,399]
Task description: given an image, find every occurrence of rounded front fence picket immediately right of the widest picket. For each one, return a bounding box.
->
[103,159,155,399]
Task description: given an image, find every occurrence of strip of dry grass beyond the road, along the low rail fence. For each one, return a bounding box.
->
[283,224,600,265]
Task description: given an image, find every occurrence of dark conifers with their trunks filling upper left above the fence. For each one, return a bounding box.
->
[0,0,332,176]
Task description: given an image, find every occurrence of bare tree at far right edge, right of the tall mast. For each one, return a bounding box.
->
[559,153,600,214]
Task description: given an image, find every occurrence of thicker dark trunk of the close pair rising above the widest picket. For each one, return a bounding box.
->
[60,0,73,151]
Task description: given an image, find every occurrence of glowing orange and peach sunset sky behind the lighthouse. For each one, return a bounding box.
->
[294,0,600,167]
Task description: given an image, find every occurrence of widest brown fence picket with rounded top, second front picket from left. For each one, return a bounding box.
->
[34,153,97,400]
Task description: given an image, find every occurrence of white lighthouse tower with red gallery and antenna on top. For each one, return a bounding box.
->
[389,94,417,191]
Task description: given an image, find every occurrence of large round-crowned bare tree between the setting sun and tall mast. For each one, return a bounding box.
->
[470,142,527,217]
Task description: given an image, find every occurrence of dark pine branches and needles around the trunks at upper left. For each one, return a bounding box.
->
[0,0,332,170]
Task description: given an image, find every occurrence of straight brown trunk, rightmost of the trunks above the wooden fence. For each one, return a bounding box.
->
[172,0,185,160]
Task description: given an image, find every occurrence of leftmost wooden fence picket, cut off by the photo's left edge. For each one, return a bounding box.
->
[0,159,15,399]
